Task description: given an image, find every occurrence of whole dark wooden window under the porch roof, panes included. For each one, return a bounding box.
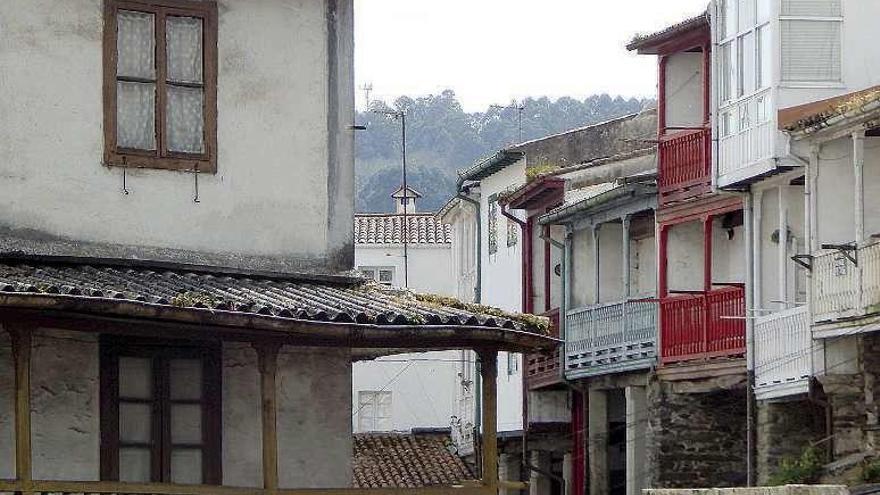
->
[101,339,222,485]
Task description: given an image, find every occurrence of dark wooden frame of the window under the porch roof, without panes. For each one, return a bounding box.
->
[100,336,223,486]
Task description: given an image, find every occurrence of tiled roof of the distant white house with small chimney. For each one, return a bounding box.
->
[354,213,452,244]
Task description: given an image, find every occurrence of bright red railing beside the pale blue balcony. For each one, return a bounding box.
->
[660,286,746,363]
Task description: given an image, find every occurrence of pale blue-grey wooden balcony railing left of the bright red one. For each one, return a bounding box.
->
[565,299,657,379]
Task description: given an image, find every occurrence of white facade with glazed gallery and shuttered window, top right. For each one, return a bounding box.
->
[710,0,880,187]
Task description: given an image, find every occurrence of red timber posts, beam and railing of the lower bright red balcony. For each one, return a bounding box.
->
[657,196,746,364]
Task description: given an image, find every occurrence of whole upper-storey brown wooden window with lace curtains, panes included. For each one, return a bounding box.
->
[104,0,217,172]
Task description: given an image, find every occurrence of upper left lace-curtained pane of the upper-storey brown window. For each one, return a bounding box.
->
[116,10,156,79]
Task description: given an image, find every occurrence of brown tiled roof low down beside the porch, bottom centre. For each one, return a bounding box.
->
[354,433,474,488]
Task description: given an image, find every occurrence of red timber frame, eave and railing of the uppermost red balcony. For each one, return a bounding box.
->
[642,25,712,206]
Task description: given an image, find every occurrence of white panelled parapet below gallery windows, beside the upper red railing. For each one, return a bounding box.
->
[718,89,776,184]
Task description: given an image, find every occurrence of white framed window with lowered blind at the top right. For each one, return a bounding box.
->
[779,0,843,84]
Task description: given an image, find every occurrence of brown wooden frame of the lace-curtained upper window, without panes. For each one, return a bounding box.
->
[103,0,218,173]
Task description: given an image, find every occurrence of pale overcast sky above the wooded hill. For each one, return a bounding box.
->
[354,0,708,112]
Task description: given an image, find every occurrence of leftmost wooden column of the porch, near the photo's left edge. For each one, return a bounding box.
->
[4,323,33,494]
